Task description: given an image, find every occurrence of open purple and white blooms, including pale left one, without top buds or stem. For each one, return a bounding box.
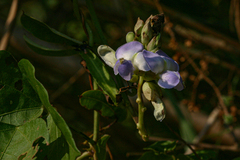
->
[98,41,184,91]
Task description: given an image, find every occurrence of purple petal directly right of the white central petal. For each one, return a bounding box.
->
[143,50,164,74]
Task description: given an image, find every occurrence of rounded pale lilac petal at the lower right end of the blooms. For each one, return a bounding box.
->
[158,71,180,89]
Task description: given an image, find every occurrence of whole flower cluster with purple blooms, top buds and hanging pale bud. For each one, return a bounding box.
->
[98,14,184,122]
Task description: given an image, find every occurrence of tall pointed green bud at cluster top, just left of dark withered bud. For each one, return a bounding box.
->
[141,15,153,45]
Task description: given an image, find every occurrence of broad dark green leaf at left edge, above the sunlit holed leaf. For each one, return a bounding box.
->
[0,51,43,126]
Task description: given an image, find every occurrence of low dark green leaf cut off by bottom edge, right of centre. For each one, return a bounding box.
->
[139,151,174,160]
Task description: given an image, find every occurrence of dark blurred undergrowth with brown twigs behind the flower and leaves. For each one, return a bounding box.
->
[0,0,240,160]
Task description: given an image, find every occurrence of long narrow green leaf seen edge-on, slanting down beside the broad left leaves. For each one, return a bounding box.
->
[18,59,80,158]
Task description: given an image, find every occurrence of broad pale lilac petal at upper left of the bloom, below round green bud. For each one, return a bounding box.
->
[116,41,144,60]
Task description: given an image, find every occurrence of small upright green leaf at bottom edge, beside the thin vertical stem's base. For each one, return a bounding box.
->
[95,135,110,160]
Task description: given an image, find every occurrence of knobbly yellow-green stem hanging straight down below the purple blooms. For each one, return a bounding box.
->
[136,76,148,141]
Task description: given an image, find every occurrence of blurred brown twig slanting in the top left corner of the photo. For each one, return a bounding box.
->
[0,0,18,50]
